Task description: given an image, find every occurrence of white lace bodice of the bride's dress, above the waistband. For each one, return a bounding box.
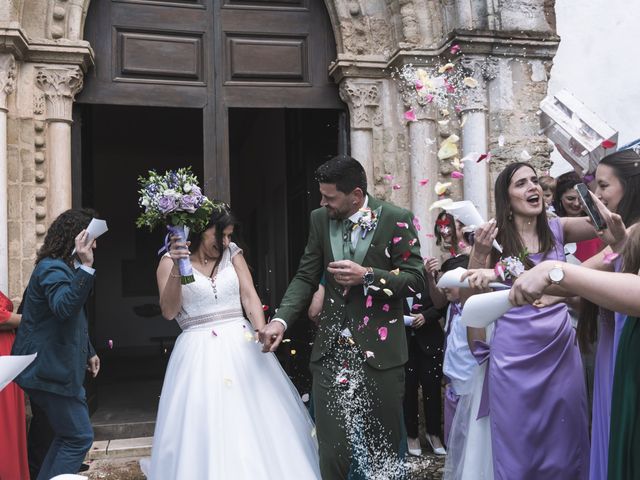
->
[176,242,242,330]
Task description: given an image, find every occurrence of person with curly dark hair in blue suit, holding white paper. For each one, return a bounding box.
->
[11,209,100,480]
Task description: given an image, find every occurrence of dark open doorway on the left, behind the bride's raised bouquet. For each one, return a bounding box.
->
[75,105,203,438]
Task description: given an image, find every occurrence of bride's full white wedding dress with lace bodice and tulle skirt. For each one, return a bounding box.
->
[141,243,320,480]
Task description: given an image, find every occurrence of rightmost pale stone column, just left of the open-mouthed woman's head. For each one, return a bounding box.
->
[462,59,495,220]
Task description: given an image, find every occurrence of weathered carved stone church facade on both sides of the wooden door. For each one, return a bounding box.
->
[0,0,559,299]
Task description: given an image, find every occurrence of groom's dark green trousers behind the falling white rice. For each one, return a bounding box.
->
[311,346,406,480]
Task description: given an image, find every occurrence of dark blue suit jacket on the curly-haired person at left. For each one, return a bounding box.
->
[11,258,95,396]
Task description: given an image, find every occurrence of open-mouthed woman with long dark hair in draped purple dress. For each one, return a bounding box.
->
[462,163,595,480]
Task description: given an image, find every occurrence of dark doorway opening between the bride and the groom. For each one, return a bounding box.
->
[229,108,348,393]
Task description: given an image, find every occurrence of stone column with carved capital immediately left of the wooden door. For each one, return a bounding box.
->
[36,66,82,220]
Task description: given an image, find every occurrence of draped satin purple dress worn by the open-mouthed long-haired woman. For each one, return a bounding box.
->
[488,219,589,480]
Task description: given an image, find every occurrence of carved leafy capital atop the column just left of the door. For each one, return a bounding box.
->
[36,66,82,123]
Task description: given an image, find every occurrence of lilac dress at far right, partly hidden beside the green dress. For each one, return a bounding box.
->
[589,257,627,480]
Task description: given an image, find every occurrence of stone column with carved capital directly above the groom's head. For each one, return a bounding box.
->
[340,78,380,186]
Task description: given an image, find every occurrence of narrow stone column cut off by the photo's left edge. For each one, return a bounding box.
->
[0,54,16,296]
